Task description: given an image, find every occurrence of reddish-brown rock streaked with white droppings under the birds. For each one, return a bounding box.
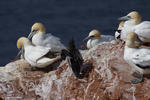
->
[0,42,150,100]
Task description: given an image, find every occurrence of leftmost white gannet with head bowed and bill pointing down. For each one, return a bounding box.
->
[17,37,60,68]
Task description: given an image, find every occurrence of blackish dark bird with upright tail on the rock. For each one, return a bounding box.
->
[61,40,92,78]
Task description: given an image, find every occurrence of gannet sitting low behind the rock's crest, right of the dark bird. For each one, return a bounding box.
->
[84,30,114,49]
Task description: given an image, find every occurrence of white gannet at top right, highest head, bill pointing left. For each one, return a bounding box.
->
[119,11,150,42]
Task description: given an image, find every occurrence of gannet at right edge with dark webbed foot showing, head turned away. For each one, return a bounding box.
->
[124,32,150,83]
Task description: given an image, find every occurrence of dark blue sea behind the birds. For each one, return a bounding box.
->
[0,0,150,66]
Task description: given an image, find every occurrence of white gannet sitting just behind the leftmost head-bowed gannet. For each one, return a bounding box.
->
[28,23,65,52]
